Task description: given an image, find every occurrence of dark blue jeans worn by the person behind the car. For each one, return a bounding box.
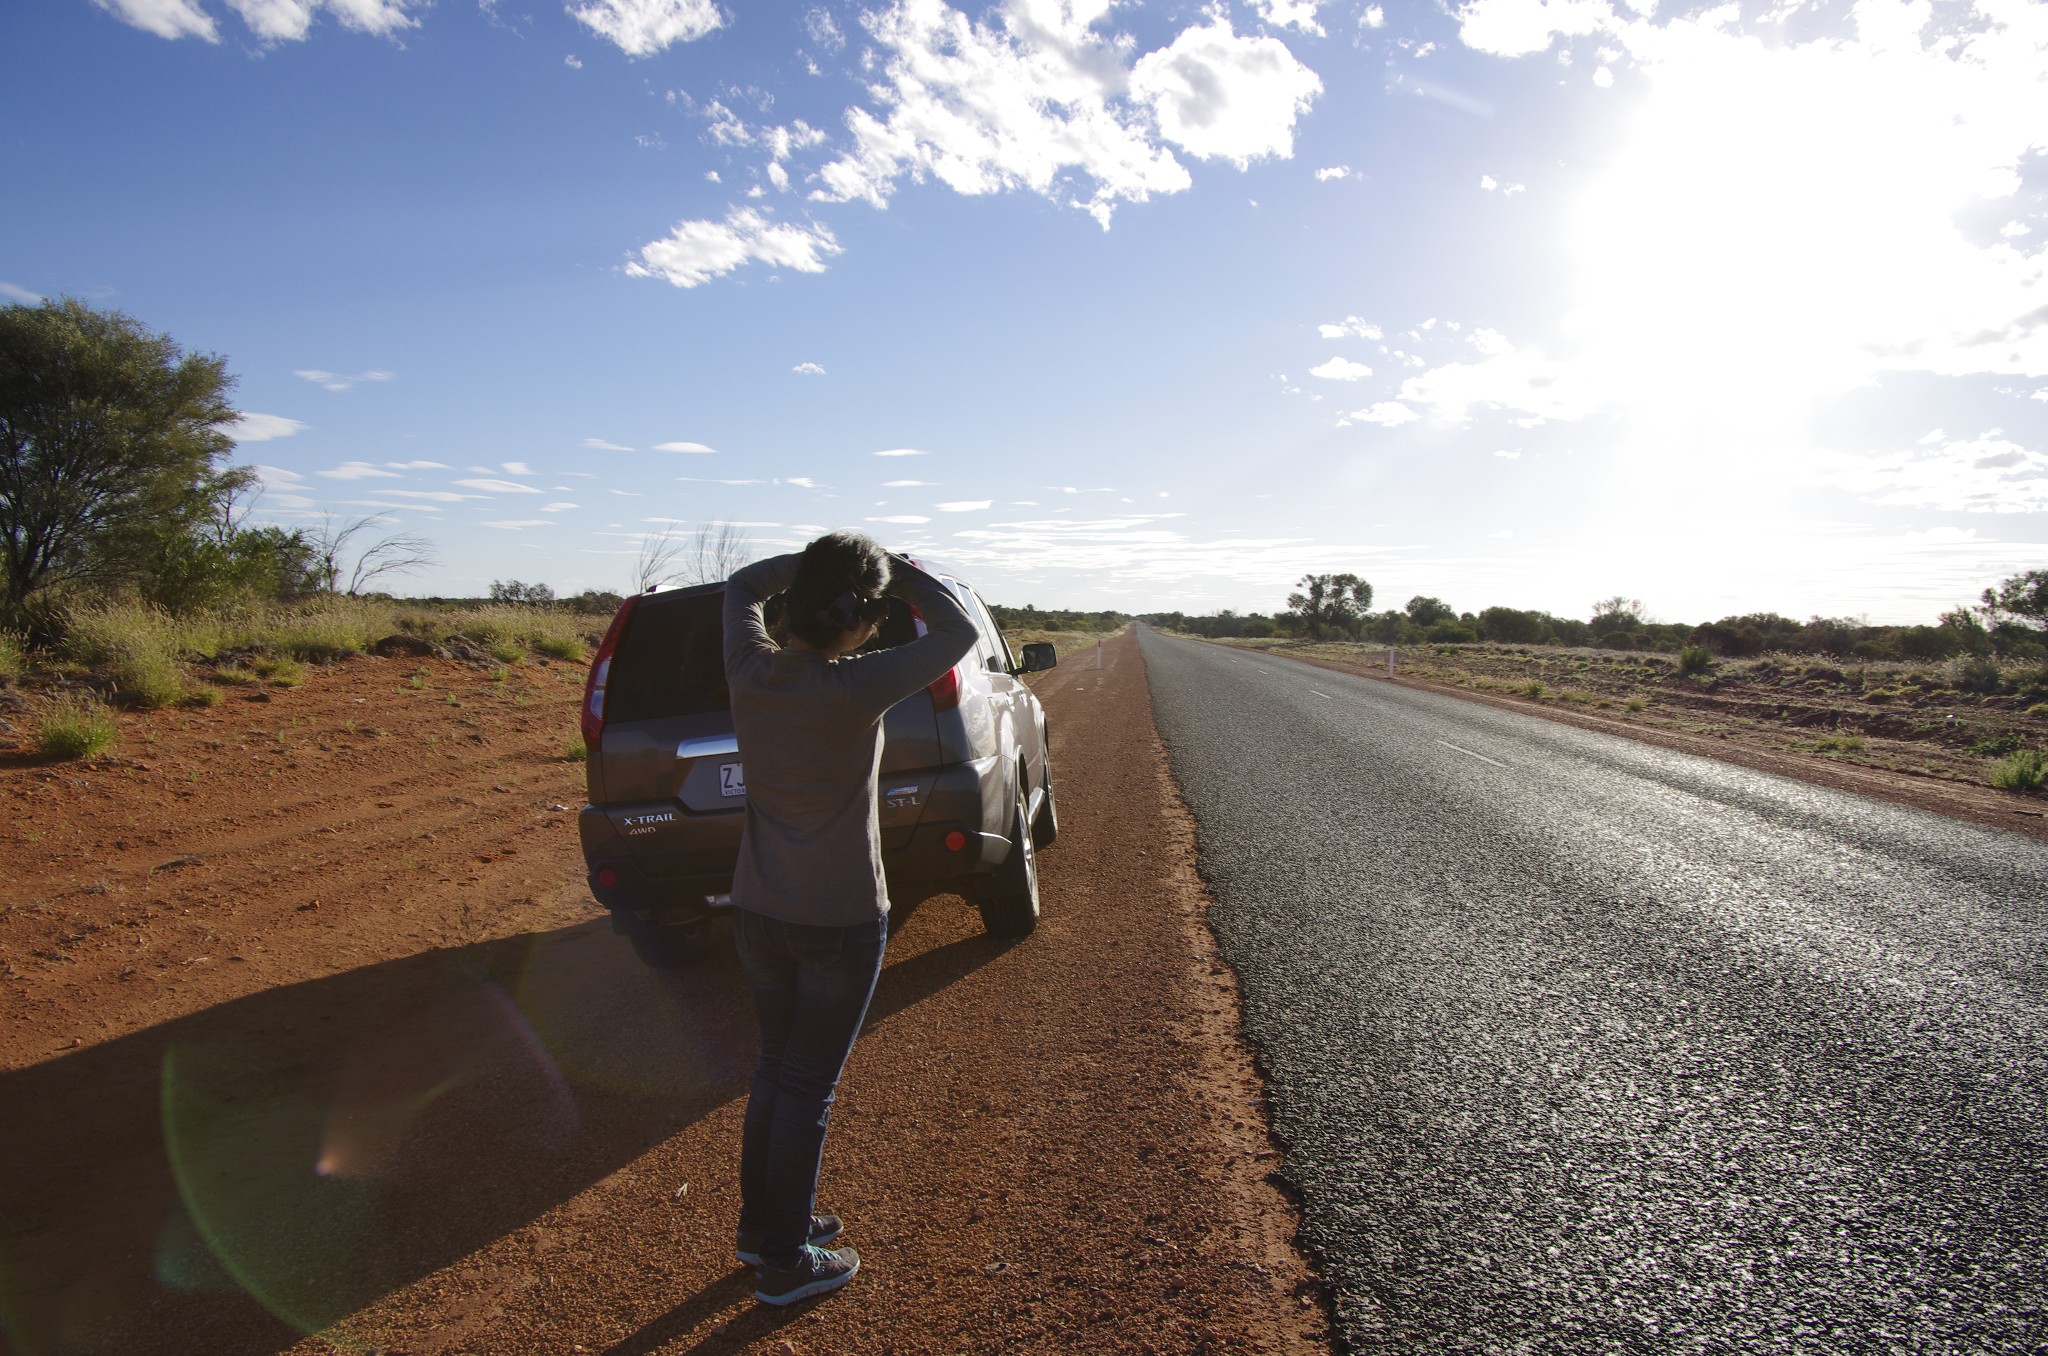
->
[733,909,889,1266]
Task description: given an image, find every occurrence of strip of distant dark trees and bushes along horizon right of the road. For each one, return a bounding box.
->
[1141,569,2048,672]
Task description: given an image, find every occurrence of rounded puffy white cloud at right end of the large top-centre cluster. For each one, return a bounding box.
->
[1130,15,1323,168]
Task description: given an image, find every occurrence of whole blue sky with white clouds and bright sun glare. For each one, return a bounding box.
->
[0,0,2048,623]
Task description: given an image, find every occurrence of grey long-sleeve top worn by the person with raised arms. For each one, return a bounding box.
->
[725,555,975,926]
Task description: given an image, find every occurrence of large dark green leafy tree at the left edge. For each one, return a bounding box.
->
[0,297,236,612]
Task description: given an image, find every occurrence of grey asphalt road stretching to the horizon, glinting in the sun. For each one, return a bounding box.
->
[1141,631,2048,1352]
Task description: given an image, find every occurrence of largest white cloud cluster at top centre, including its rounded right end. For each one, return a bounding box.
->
[813,0,1321,227]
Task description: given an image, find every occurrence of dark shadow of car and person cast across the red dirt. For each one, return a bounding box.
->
[0,922,999,1356]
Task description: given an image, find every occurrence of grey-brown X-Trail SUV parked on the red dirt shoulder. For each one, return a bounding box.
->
[578,561,1059,967]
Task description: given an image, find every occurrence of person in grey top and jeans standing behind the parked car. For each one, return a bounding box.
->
[725,533,975,1305]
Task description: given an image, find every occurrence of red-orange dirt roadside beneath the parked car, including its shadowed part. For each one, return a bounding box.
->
[0,635,1329,1356]
